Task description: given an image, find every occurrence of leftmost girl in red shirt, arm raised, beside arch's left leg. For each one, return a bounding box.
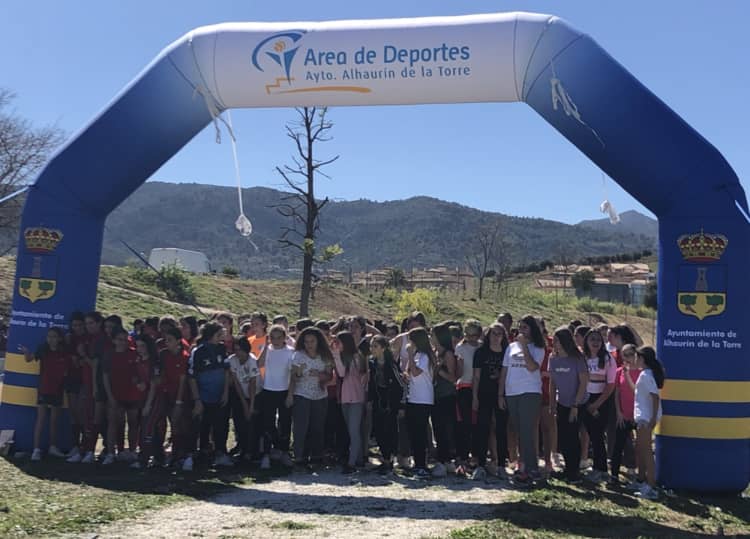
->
[20,327,70,461]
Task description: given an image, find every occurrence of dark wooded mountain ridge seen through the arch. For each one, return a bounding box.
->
[97,182,655,278]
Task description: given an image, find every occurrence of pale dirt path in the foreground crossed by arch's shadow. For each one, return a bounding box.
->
[86,471,510,539]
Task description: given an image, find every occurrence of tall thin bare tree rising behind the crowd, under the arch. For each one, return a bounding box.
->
[274,107,342,317]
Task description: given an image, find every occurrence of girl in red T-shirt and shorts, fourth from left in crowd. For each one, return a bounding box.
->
[102,327,146,465]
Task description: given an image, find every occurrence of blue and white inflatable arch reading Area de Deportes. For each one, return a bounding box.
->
[0,13,750,491]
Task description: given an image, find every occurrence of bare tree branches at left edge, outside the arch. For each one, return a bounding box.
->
[0,88,63,254]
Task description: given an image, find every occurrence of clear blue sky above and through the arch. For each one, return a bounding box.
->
[0,0,750,222]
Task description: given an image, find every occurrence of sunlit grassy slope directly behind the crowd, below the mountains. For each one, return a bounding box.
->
[0,257,654,348]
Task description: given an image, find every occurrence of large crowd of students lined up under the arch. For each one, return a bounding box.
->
[21,312,665,498]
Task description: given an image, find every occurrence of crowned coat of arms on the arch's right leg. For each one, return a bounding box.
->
[677,229,729,320]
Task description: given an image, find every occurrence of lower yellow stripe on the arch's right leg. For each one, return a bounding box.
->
[656,415,750,440]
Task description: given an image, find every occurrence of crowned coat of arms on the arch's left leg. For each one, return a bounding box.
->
[18,228,63,303]
